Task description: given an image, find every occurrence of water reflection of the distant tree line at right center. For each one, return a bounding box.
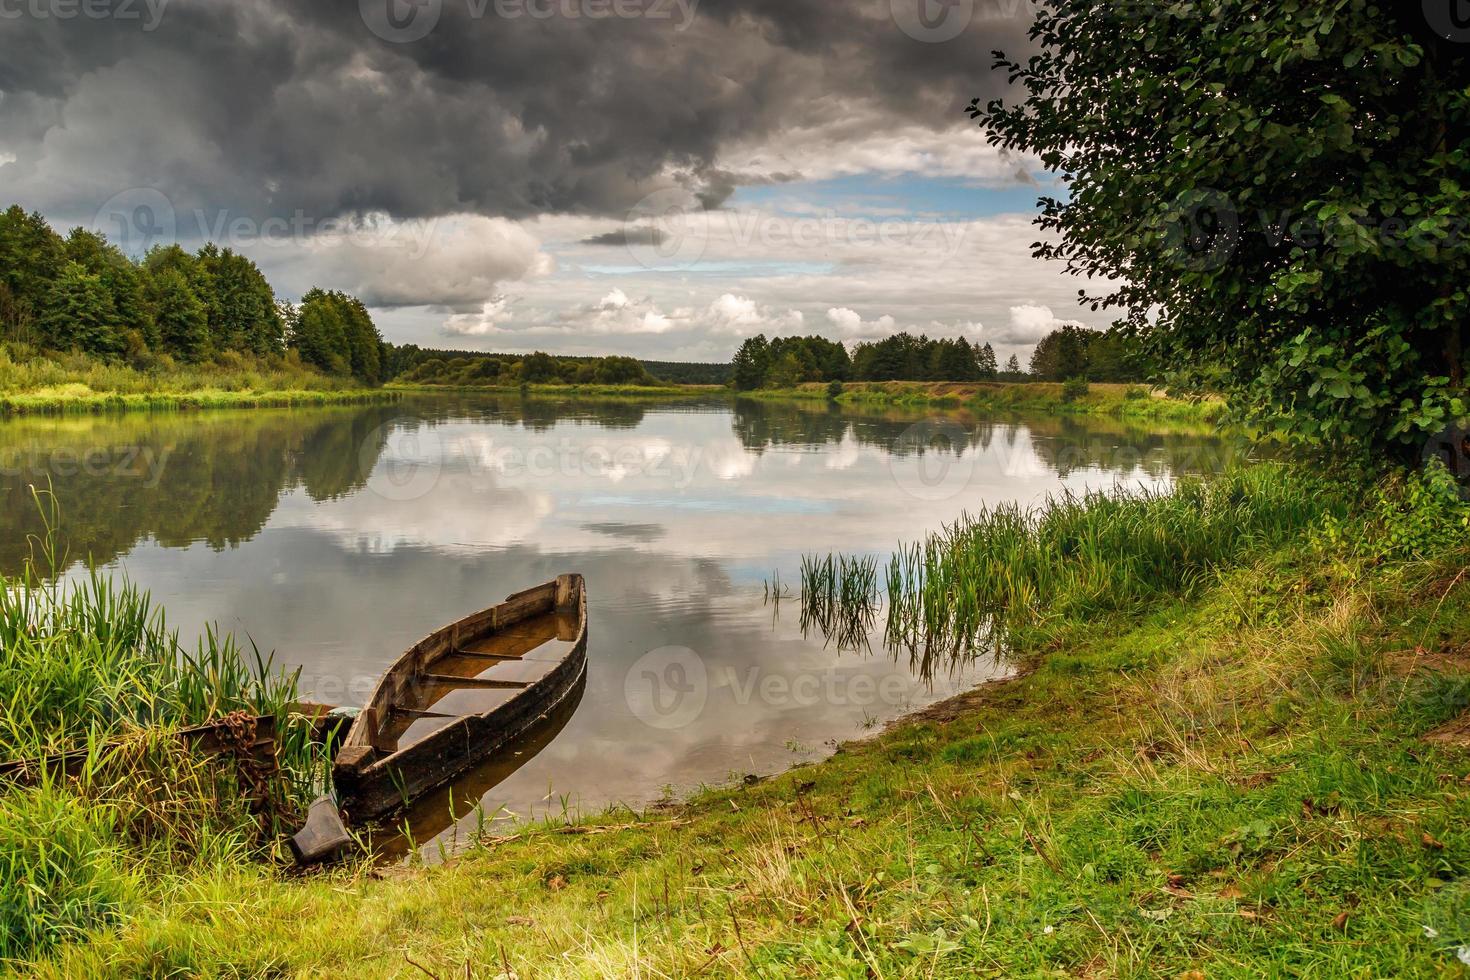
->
[732,398,1238,478]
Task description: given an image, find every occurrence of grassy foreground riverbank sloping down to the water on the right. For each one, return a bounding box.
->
[14,472,1470,977]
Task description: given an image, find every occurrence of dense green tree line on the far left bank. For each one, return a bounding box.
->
[0,206,388,383]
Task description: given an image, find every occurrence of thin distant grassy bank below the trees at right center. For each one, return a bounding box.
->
[741,381,1225,422]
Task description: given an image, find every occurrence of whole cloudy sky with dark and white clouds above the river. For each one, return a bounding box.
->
[0,0,1108,361]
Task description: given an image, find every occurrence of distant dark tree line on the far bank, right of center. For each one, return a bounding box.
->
[731,323,1147,391]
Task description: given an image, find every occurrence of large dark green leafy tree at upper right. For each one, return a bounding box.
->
[970,0,1470,457]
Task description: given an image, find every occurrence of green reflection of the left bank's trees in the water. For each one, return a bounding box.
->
[0,406,398,574]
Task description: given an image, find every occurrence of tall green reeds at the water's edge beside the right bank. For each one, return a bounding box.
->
[886,464,1348,664]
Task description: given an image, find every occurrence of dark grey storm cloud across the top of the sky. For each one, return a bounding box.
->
[0,0,1029,224]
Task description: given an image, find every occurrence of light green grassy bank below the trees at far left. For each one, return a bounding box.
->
[0,347,398,414]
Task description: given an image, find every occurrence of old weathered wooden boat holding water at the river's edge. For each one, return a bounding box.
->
[332,574,587,824]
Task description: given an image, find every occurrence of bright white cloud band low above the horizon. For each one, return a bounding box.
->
[370,208,1111,361]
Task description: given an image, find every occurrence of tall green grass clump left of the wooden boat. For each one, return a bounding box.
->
[0,492,326,958]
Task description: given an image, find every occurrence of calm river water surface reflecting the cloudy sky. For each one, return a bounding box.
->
[0,397,1220,839]
